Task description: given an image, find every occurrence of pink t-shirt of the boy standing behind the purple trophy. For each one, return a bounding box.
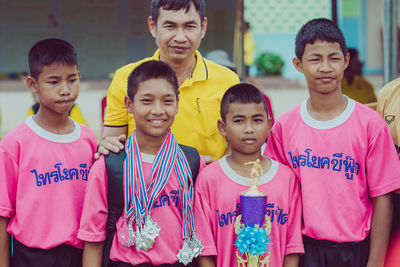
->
[195,157,304,267]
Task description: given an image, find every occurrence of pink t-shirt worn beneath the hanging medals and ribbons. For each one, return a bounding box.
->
[78,153,204,265]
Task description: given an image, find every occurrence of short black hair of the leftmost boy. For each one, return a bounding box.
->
[28,38,78,80]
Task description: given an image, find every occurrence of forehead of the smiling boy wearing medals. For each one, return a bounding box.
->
[136,78,176,96]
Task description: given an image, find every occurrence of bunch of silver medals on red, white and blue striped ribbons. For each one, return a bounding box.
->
[124,131,203,264]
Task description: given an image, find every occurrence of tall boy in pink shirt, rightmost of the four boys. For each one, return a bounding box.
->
[266,19,400,267]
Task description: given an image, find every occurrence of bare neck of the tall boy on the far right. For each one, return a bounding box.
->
[307,91,347,121]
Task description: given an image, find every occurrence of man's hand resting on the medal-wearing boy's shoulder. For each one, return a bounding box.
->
[94,126,128,159]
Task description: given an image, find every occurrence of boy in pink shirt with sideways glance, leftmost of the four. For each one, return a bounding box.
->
[0,39,96,267]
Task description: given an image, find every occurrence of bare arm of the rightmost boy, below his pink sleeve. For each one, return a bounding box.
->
[367,193,393,267]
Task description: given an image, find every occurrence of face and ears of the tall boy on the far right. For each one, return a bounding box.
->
[293,40,349,97]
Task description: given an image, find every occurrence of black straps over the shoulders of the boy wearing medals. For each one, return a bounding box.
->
[102,145,200,267]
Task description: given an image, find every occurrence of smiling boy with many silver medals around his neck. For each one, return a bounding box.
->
[78,61,204,266]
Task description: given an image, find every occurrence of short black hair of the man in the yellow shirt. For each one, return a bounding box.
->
[151,0,206,23]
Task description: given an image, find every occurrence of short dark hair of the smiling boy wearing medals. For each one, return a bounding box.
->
[127,60,179,101]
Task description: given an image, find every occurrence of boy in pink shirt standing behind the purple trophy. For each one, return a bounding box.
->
[195,83,304,267]
